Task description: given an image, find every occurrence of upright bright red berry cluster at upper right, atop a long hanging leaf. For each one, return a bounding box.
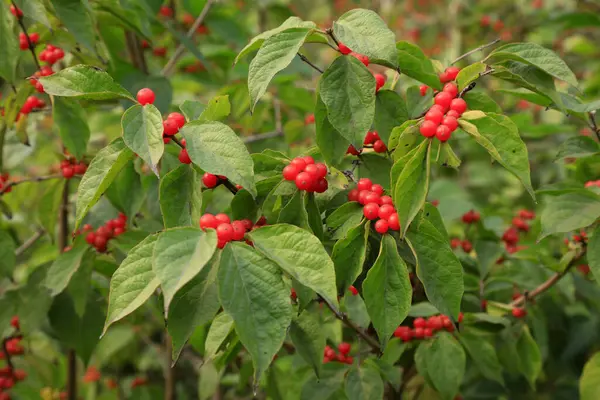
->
[419,82,467,142]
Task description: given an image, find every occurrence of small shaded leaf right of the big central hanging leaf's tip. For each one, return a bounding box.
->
[290,310,325,377]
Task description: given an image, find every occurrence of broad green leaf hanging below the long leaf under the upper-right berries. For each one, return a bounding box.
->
[407,219,464,319]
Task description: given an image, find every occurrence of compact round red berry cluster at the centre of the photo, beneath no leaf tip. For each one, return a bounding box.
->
[282,156,329,193]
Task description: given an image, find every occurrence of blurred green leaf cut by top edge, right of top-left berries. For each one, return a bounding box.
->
[52,0,96,51]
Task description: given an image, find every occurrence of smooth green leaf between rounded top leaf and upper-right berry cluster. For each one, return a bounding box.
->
[396,41,442,90]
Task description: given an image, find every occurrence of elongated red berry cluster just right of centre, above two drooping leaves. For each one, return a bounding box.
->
[348,178,400,235]
